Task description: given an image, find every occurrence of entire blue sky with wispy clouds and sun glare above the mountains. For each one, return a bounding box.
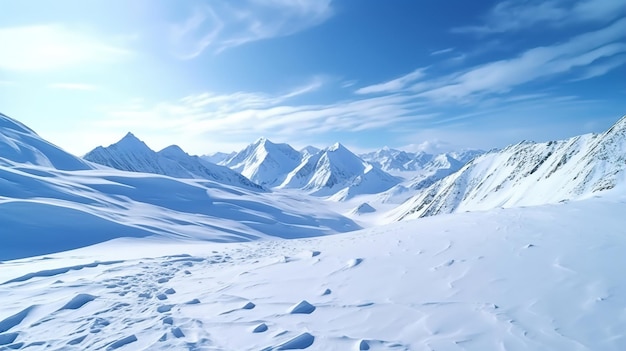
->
[0,0,626,154]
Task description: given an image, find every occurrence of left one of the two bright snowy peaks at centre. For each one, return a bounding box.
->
[221,138,302,187]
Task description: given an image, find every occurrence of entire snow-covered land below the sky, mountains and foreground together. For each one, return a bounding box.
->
[0,114,626,350]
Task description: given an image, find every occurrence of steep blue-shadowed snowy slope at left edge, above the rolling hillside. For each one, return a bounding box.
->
[0,113,93,171]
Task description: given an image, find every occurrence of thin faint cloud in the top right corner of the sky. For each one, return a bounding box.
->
[452,0,625,34]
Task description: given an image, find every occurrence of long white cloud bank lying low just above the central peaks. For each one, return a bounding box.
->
[94,76,435,152]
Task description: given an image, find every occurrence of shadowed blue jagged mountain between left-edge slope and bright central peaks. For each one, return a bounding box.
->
[84,133,262,190]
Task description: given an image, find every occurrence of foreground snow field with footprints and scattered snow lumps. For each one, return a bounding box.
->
[0,197,626,351]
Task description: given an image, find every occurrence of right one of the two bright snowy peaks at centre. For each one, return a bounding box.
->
[280,143,399,201]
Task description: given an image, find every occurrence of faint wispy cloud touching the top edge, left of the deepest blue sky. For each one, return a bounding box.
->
[170,0,333,59]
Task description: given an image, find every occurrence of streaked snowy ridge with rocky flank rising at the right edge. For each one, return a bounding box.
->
[393,117,626,219]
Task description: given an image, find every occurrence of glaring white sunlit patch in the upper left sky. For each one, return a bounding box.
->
[0,25,130,71]
